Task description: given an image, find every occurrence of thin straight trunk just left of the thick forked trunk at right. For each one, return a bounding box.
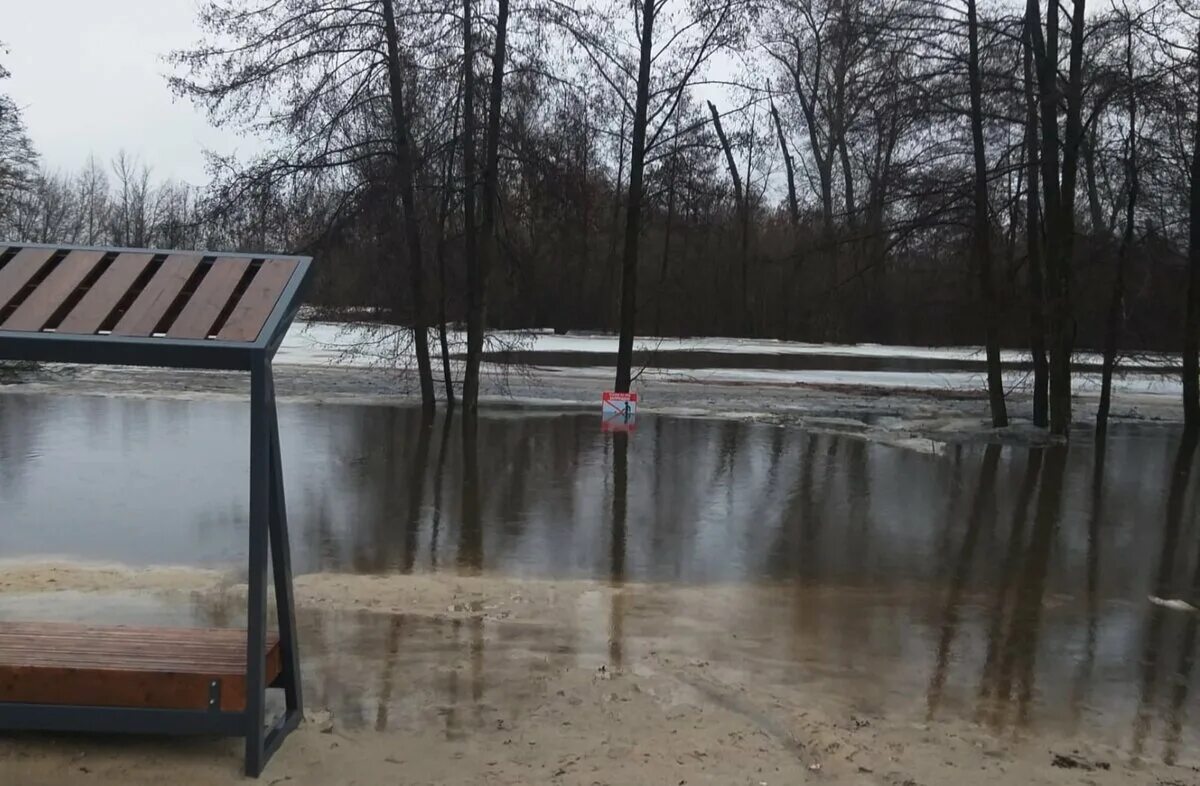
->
[1025,31,1050,428]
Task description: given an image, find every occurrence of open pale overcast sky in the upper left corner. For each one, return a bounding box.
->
[0,0,256,184]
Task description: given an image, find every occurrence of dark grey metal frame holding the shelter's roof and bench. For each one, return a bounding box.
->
[0,244,312,778]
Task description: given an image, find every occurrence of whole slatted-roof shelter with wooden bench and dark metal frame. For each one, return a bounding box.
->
[0,242,312,776]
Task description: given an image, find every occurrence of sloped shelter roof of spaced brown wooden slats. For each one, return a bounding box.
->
[0,242,312,368]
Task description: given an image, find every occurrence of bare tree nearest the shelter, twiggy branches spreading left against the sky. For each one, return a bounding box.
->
[172,0,451,408]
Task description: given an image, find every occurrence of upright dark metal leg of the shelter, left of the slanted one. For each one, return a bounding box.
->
[246,362,271,778]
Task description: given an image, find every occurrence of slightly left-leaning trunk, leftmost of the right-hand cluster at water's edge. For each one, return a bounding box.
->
[967,0,1008,428]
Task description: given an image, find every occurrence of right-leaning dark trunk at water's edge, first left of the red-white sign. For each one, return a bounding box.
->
[462,0,509,413]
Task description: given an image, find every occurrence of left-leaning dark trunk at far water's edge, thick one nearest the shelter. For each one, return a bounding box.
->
[383,0,434,409]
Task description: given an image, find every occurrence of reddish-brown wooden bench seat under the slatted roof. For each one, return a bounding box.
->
[0,622,282,712]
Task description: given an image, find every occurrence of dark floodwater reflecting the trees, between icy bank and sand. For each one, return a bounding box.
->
[0,395,1200,761]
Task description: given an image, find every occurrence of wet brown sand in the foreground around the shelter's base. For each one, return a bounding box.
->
[0,563,1200,786]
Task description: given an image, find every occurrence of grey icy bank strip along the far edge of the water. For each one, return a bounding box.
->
[0,362,1183,452]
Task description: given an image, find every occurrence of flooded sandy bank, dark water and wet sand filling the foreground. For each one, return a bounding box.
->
[0,391,1200,786]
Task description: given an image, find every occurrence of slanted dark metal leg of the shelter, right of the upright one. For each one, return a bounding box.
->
[266,366,304,718]
